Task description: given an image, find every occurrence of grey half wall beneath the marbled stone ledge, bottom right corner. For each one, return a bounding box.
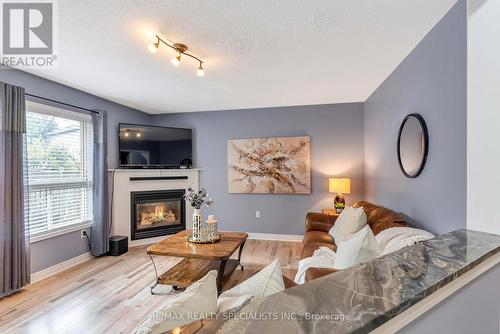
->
[398,264,500,334]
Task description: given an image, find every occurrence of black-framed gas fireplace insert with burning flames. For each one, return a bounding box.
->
[130,189,186,240]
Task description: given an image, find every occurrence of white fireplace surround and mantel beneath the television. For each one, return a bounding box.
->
[109,169,200,246]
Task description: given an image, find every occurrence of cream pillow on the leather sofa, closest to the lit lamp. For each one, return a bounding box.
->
[329,206,367,246]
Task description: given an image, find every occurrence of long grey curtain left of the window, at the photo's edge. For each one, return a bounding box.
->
[0,82,30,296]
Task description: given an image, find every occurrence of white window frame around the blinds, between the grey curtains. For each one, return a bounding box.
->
[25,99,93,243]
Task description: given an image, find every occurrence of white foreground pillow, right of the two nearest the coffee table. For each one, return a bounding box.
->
[217,260,285,312]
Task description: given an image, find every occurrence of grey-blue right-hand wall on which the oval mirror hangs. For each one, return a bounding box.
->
[364,0,467,233]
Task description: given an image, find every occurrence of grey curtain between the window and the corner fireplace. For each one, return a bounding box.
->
[90,111,110,256]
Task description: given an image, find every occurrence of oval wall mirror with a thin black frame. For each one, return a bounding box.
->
[398,114,429,178]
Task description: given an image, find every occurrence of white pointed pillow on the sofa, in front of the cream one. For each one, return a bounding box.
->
[335,225,381,269]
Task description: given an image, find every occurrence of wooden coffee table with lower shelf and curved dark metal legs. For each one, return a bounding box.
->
[147,230,248,294]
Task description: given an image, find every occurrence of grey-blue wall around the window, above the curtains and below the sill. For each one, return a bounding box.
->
[0,69,151,272]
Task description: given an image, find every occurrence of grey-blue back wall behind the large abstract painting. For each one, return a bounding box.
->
[154,103,364,234]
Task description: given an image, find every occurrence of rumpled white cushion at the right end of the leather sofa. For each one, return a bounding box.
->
[375,227,435,255]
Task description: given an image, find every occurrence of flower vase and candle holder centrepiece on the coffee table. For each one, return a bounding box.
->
[184,188,219,243]
